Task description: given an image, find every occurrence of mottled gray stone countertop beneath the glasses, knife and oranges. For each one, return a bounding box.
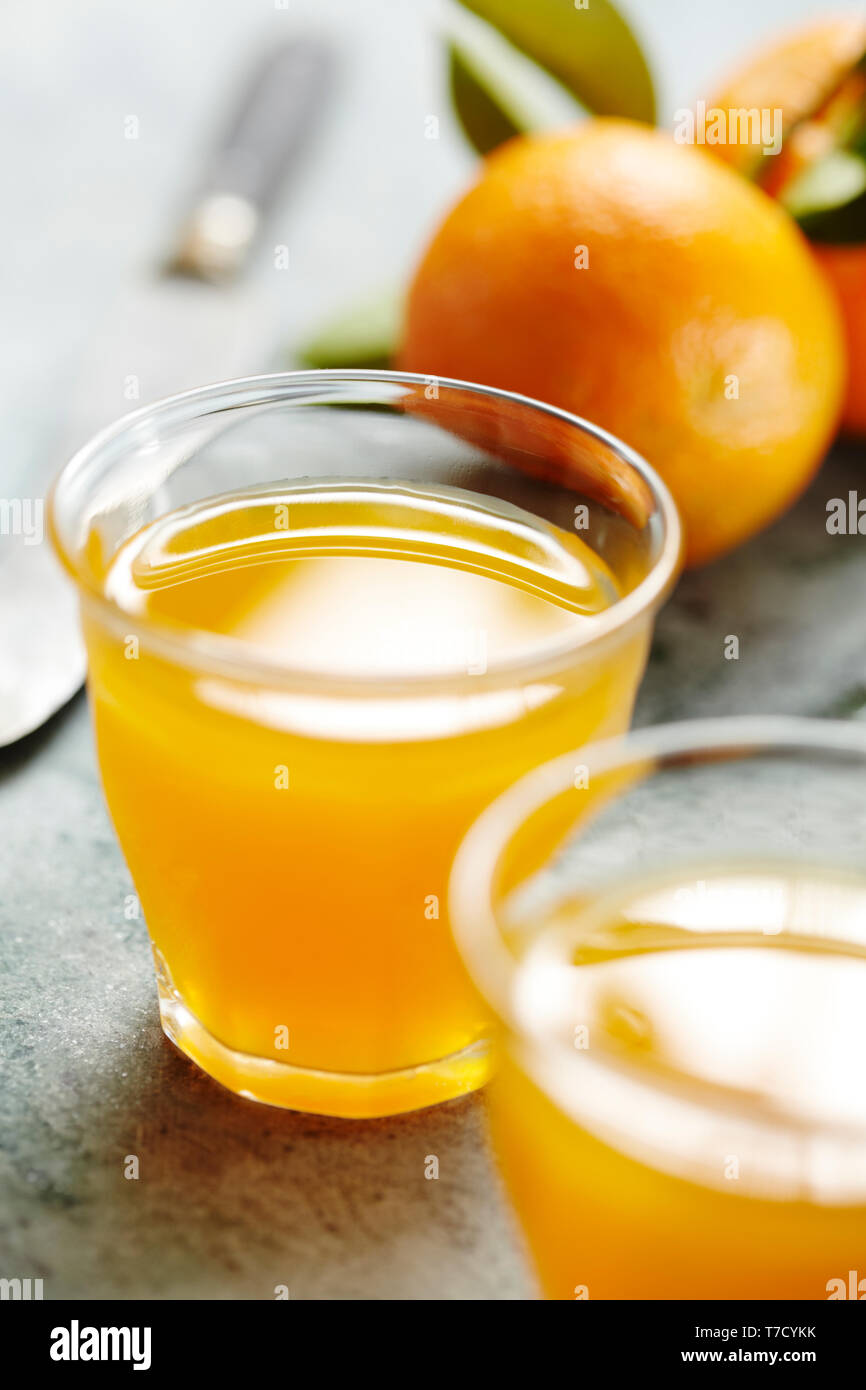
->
[0,0,866,1298]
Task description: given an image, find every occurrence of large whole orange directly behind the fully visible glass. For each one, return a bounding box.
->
[400,120,844,564]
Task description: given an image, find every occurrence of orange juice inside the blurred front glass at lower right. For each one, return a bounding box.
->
[491,866,866,1300]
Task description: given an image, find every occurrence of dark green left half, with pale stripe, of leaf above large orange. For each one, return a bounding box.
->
[443,6,587,154]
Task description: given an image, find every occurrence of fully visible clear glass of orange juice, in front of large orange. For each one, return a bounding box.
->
[51,371,680,1116]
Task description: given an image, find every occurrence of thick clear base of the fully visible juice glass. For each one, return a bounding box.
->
[157,976,491,1119]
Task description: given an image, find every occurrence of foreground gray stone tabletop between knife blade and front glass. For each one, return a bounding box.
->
[0,698,536,1298]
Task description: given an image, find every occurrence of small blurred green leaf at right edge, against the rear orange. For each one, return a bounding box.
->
[781,150,866,243]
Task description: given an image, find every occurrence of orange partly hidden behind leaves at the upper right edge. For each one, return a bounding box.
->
[712,15,866,434]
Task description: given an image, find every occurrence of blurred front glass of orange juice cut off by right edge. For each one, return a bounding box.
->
[450,719,866,1300]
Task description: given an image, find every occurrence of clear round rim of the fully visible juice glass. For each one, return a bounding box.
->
[47,368,683,696]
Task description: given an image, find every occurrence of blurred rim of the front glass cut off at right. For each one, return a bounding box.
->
[448,714,866,1143]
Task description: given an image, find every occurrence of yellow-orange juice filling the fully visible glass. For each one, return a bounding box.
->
[85,481,646,1113]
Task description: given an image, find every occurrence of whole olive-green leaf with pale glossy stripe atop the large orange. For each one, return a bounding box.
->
[448,0,655,153]
